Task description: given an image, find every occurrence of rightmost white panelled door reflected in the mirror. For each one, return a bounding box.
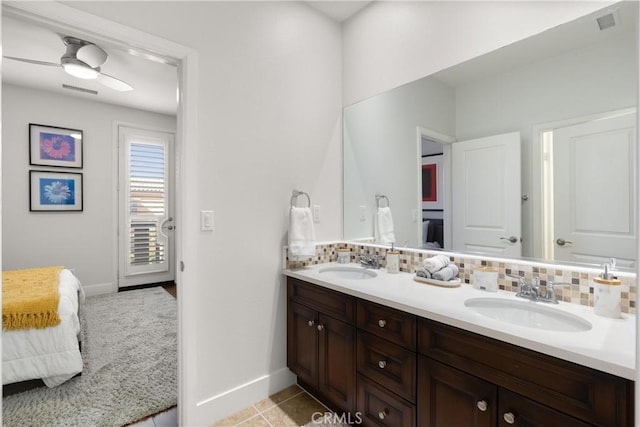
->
[552,112,636,266]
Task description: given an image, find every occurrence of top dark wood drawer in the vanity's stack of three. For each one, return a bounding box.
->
[357,300,416,350]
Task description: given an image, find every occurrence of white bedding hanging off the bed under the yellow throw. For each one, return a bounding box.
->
[2,269,84,387]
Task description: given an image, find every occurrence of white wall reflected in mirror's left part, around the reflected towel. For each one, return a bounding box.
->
[344,78,456,247]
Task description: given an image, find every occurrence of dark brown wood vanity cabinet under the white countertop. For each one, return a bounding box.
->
[287,277,634,427]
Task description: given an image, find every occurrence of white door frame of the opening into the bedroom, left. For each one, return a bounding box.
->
[2,1,198,425]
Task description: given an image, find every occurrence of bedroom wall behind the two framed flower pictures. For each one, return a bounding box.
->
[2,84,176,292]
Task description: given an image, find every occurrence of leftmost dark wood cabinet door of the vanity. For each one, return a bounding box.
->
[287,302,318,386]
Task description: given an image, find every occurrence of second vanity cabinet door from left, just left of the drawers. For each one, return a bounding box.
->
[317,314,356,412]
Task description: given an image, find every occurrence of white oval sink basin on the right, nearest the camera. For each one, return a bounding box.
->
[464,298,592,332]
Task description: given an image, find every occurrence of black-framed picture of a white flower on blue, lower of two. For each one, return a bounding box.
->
[29,170,82,212]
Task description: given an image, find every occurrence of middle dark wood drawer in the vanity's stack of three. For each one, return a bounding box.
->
[356,331,416,403]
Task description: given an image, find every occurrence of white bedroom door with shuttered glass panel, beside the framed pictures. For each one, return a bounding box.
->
[118,126,175,287]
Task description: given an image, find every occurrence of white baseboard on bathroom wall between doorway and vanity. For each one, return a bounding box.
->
[195,368,296,425]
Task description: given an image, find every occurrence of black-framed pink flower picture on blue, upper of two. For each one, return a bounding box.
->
[29,123,82,168]
